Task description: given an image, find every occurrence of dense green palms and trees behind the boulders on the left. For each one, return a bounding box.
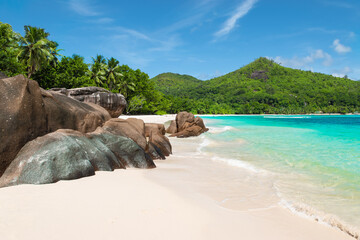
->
[0,22,168,114]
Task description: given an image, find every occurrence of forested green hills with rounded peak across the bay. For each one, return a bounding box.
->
[153,58,360,114]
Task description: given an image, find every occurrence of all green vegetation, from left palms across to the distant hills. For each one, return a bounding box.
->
[0,22,360,114]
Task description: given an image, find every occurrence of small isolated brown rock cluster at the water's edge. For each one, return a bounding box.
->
[166,112,209,138]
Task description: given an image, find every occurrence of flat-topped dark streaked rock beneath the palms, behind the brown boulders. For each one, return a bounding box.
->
[51,87,126,118]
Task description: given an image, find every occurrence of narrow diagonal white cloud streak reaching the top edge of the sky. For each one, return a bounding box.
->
[215,0,258,37]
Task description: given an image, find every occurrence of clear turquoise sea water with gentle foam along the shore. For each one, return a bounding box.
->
[202,115,360,235]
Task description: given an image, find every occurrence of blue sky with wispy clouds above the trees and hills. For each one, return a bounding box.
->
[0,0,360,80]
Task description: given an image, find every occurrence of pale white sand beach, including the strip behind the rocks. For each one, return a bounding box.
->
[0,115,354,240]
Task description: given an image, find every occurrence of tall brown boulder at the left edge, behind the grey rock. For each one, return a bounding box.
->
[0,75,48,176]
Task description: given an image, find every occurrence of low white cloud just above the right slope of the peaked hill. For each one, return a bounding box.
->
[270,49,333,68]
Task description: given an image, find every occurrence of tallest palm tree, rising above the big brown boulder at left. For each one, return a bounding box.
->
[18,26,58,78]
